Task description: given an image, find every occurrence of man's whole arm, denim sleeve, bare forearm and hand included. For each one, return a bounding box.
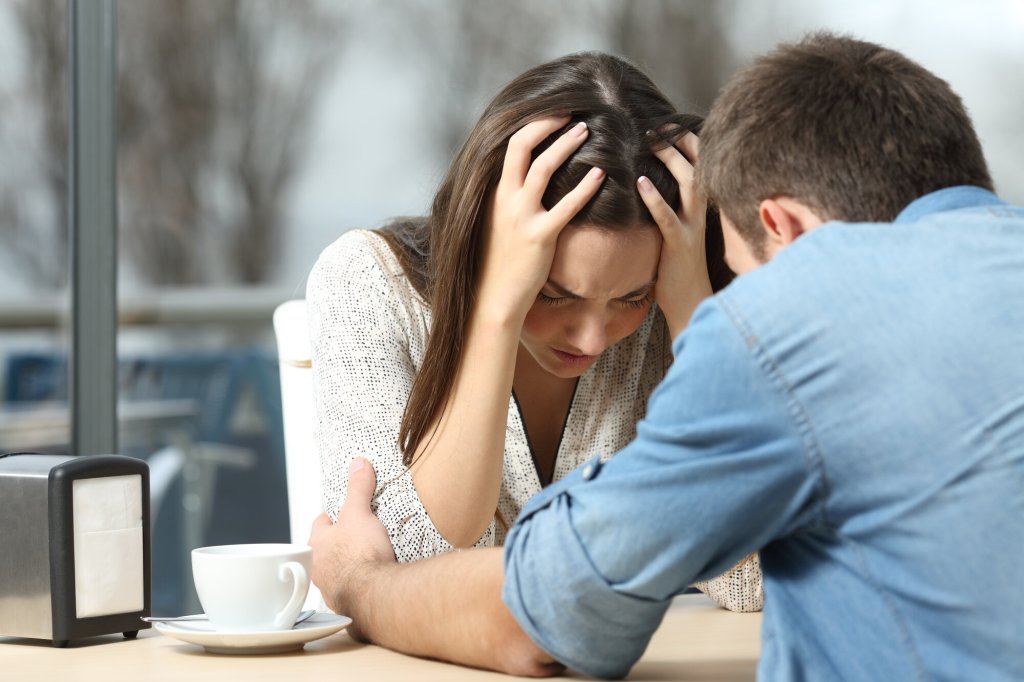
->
[310,295,824,677]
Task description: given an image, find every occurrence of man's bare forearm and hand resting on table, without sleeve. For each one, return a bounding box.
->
[309,458,562,677]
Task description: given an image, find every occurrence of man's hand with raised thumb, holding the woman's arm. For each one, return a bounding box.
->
[309,458,395,639]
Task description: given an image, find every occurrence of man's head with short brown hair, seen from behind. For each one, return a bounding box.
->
[697,33,992,269]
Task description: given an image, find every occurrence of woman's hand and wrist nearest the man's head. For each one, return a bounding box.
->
[637,132,712,338]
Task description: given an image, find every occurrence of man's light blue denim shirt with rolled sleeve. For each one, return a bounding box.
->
[504,187,1024,682]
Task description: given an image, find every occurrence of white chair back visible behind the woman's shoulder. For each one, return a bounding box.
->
[273,300,326,610]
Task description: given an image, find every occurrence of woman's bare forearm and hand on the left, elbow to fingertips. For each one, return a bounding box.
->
[412,115,604,547]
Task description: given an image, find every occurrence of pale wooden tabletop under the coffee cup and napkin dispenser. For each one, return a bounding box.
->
[0,595,761,682]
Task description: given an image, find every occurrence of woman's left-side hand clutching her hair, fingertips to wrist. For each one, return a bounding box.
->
[477,116,604,324]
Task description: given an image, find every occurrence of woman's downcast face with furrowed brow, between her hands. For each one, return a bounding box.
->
[520,225,662,379]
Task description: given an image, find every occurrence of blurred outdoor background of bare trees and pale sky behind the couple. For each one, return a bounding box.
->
[0,0,1024,614]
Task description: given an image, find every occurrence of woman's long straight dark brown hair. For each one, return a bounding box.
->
[382,52,732,465]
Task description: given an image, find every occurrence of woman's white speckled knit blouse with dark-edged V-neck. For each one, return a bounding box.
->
[306,230,762,610]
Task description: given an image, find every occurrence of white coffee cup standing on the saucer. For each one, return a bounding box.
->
[191,544,313,632]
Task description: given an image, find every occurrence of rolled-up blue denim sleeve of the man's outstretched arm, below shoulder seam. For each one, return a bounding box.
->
[503,296,818,678]
